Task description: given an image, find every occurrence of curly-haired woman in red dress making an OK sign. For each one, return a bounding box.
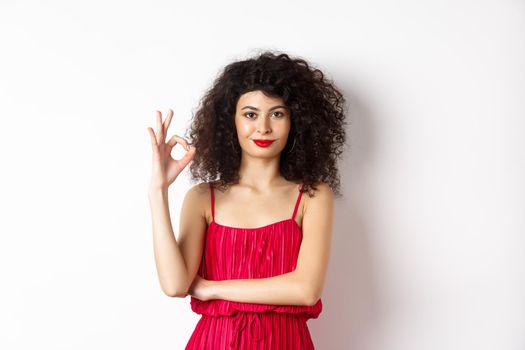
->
[148,52,345,349]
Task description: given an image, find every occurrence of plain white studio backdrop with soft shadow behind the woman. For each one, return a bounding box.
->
[0,0,525,350]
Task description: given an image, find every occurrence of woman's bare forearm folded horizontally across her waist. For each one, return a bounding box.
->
[209,271,314,305]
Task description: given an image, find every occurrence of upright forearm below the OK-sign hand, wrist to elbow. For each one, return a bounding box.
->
[148,188,188,296]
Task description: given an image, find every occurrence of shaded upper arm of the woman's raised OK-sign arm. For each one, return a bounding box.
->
[177,183,209,291]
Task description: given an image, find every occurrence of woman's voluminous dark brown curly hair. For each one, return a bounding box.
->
[184,51,346,196]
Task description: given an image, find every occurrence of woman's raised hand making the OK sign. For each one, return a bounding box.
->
[148,109,195,188]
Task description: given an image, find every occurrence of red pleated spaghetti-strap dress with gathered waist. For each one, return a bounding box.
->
[185,184,322,350]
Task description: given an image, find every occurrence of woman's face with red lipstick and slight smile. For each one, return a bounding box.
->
[235,90,291,158]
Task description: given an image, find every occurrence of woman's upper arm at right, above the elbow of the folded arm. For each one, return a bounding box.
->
[295,183,334,304]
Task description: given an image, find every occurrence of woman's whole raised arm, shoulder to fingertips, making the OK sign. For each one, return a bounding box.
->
[148,110,202,297]
